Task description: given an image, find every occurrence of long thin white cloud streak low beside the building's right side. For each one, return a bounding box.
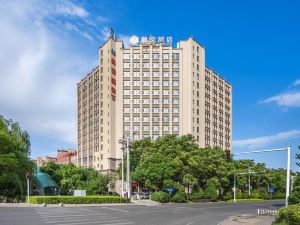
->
[233,130,300,149]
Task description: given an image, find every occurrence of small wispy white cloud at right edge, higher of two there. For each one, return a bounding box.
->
[261,91,300,107]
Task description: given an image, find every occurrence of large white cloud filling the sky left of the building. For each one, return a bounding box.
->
[0,0,108,149]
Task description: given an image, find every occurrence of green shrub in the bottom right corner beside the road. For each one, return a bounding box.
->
[277,205,300,225]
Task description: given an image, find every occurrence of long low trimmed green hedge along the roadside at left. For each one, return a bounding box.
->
[29,196,126,204]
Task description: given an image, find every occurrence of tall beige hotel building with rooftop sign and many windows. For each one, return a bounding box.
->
[77,34,232,172]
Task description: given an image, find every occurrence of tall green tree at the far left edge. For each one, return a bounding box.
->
[0,116,33,199]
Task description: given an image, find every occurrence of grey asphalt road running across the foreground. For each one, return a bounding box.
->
[0,201,283,225]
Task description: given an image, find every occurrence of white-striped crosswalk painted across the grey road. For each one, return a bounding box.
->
[35,207,134,225]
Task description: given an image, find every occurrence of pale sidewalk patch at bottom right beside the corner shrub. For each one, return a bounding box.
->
[218,214,275,225]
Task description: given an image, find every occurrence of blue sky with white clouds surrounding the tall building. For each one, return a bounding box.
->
[0,0,300,169]
